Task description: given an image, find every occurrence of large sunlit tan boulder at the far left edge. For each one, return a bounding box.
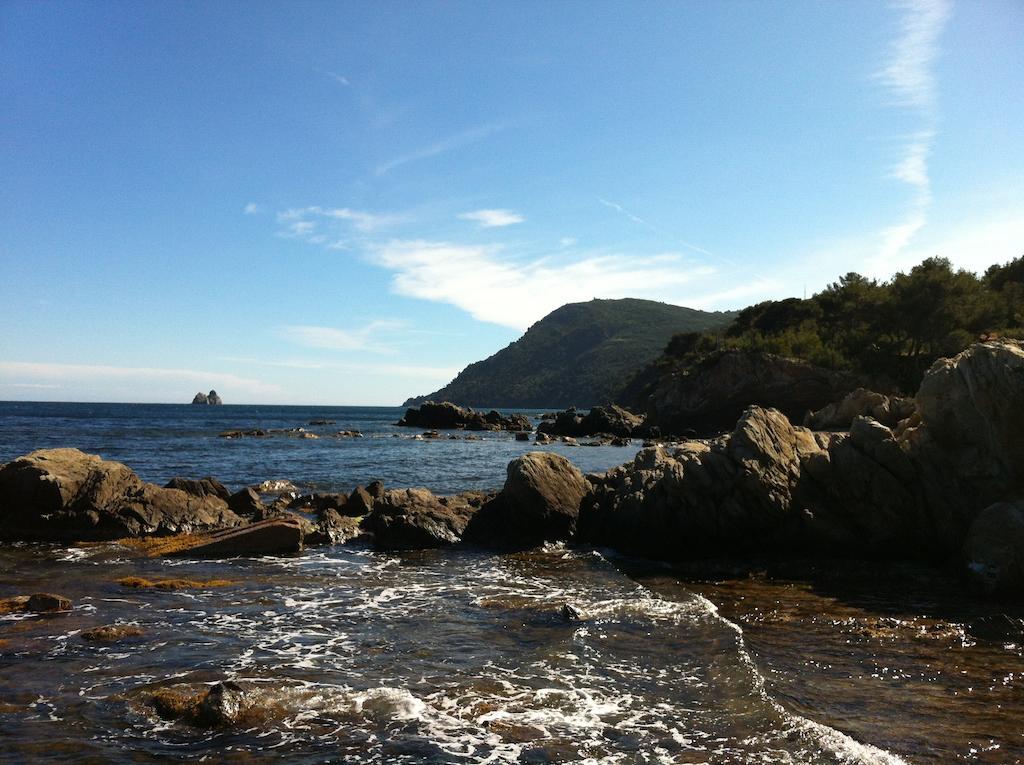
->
[0,449,242,542]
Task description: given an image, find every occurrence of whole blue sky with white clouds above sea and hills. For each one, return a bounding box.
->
[0,0,1024,405]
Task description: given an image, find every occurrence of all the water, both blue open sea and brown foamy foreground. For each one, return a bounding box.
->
[0,402,1024,765]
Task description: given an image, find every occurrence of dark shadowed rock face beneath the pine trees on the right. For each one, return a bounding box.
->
[634,350,858,435]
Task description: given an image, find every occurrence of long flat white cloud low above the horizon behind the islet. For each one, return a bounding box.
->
[0,362,282,403]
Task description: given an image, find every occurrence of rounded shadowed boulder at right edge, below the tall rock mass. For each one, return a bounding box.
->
[964,501,1024,595]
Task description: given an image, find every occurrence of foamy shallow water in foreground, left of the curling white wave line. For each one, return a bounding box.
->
[0,547,921,763]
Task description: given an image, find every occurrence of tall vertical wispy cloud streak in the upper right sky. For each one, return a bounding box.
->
[876,0,950,262]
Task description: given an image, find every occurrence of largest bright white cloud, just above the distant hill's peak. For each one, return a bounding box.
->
[373,240,714,329]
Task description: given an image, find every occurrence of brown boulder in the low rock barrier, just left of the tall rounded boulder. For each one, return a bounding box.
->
[365,488,483,550]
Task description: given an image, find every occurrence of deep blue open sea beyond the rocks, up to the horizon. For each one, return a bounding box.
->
[0,401,639,494]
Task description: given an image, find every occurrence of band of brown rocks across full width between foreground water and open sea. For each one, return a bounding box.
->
[0,341,1024,598]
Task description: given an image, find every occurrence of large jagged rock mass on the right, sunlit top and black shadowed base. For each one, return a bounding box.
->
[578,342,1024,594]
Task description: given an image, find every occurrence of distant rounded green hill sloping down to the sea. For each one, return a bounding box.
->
[404,298,736,409]
